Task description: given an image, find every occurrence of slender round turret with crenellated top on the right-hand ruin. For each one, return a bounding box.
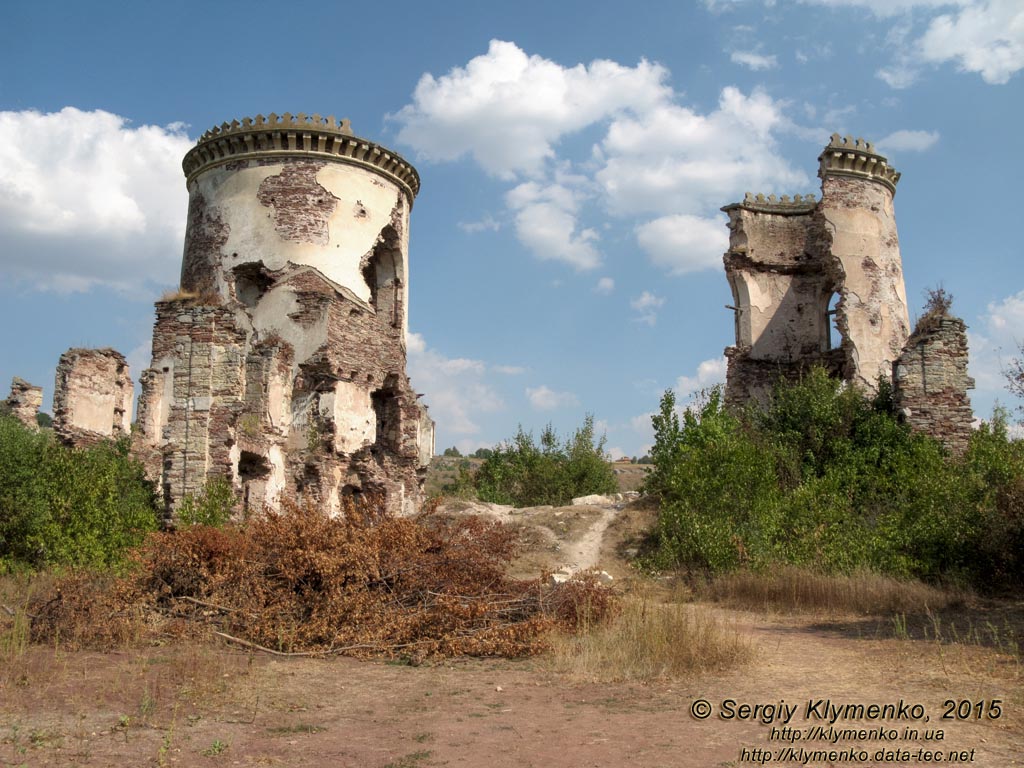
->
[818,133,910,390]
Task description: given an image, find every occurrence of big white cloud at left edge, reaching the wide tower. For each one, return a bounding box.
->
[0,106,194,292]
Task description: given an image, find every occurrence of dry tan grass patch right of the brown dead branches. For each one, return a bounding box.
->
[551,592,753,682]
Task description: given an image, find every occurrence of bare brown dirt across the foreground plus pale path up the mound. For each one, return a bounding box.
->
[0,483,1024,768]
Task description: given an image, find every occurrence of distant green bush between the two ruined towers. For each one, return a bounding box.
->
[473,415,618,507]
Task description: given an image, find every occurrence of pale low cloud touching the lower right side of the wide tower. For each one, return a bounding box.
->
[407,333,505,435]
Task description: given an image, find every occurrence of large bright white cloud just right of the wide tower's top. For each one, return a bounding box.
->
[392,40,669,178]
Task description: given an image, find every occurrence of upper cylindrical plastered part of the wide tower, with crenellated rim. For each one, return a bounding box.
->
[181,113,420,332]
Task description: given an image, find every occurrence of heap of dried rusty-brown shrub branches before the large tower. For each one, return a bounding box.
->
[28,503,611,658]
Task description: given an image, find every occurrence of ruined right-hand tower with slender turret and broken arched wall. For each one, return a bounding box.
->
[722,134,910,402]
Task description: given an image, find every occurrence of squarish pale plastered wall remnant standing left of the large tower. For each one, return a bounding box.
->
[53,348,135,445]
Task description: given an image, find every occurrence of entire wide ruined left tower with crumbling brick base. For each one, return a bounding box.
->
[135,114,433,517]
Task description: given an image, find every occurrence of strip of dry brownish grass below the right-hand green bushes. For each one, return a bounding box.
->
[703,566,967,614]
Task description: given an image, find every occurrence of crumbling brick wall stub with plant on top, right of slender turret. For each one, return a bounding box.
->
[892,316,974,454]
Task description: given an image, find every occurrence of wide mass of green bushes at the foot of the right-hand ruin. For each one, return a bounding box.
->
[646,369,1024,591]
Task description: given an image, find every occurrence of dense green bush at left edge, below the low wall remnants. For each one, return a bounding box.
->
[0,417,158,569]
